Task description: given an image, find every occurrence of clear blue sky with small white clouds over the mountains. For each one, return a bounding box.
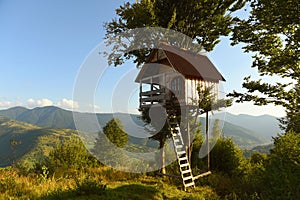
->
[0,0,284,117]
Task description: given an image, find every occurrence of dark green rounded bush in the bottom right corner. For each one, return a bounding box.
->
[263,131,300,199]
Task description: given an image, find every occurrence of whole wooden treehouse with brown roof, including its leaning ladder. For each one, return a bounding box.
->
[135,44,225,189]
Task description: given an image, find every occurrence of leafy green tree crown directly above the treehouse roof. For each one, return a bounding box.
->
[105,0,245,66]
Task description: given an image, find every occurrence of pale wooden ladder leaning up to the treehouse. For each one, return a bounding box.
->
[169,117,195,191]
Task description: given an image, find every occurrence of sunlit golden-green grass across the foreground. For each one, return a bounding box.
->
[0,167,219,200]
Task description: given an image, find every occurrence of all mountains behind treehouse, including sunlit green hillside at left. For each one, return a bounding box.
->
[0,106,280,167]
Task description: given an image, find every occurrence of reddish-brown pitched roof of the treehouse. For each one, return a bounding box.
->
[135,43,225,82]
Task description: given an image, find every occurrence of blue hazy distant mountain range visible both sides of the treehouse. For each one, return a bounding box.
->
[0,106,279,148]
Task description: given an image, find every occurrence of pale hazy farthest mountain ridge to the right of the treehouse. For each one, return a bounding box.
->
[214,113,282,142]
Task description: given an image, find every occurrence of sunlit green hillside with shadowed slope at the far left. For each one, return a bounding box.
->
[0,115,77,167]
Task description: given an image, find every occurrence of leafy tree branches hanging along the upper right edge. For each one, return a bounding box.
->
[230,0,300,132]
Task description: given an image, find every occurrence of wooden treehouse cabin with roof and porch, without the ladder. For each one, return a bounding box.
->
[135,44,225,109]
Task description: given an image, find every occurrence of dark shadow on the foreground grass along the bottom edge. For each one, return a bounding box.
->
[40,184,162,200]
